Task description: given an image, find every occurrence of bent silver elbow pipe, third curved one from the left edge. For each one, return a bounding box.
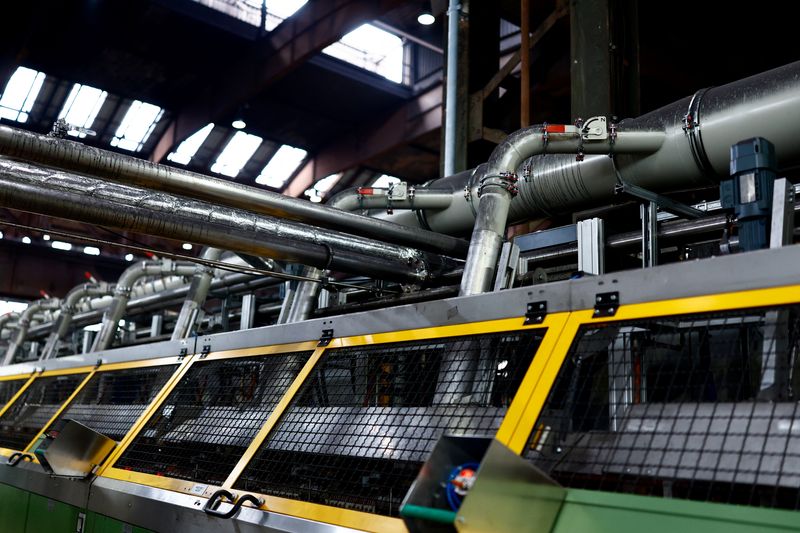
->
[91,260,195,352]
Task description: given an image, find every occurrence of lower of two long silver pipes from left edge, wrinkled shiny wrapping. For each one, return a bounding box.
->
[0,159,453,282]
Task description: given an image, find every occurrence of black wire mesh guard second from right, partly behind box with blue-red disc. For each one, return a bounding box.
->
[234,330,544,516]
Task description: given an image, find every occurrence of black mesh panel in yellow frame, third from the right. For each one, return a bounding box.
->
[115,351,312,485]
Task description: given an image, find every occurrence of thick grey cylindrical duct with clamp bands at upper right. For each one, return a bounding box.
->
[384,62,800,235]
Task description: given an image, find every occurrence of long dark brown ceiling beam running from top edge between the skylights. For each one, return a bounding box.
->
[150,0,401,162]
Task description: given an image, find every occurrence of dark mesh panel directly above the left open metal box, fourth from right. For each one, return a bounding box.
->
[46,365,178,441]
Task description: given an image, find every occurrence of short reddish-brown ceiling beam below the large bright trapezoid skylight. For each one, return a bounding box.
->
[284,85,442,197]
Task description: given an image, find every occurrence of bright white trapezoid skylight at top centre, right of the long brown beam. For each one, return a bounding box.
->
[322,24,404,83]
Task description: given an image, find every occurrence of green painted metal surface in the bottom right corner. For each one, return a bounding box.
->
[552,489,800,533]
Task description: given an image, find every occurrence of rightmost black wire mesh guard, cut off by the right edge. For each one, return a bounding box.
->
[524,306,800,509]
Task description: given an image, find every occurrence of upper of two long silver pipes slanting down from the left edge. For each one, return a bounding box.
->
[0,126,468,258]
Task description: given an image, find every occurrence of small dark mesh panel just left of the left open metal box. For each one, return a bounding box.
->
[0,374,87,450]
